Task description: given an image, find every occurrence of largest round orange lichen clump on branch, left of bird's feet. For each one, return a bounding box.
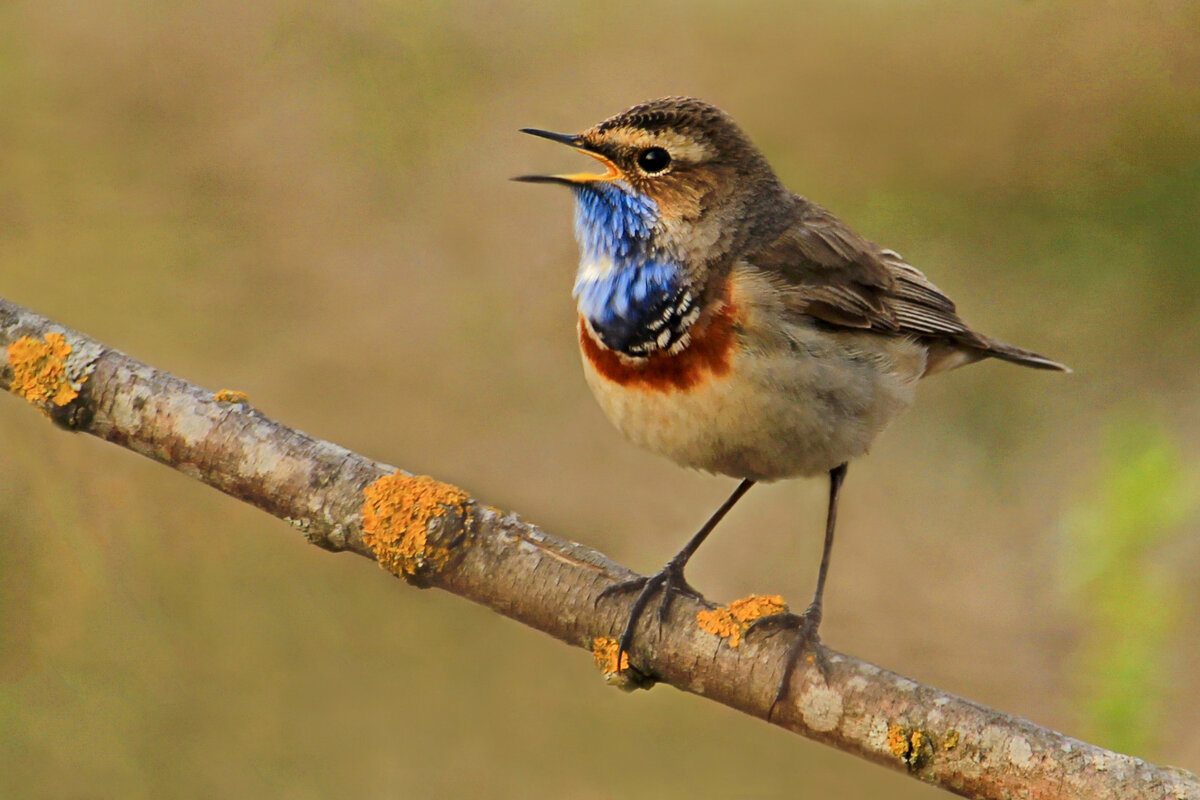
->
[362,473,470,579]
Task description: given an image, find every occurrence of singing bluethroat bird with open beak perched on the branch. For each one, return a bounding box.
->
[516,97,1068,703]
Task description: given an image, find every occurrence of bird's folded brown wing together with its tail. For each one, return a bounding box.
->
[746,198,1067,374]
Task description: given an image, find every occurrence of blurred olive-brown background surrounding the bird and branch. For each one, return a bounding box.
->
[0,0,1200,799]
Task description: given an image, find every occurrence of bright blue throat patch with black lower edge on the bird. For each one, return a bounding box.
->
[574,181,691,356]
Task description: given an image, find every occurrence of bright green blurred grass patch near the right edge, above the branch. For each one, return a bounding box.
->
[1063,419,1200,752]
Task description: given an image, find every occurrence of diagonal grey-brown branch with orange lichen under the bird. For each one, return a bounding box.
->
[0,299,1200,800]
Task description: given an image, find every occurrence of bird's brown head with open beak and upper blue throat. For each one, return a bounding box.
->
[516,97,787,272]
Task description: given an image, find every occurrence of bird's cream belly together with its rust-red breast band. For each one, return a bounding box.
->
[581,316,924,481]
